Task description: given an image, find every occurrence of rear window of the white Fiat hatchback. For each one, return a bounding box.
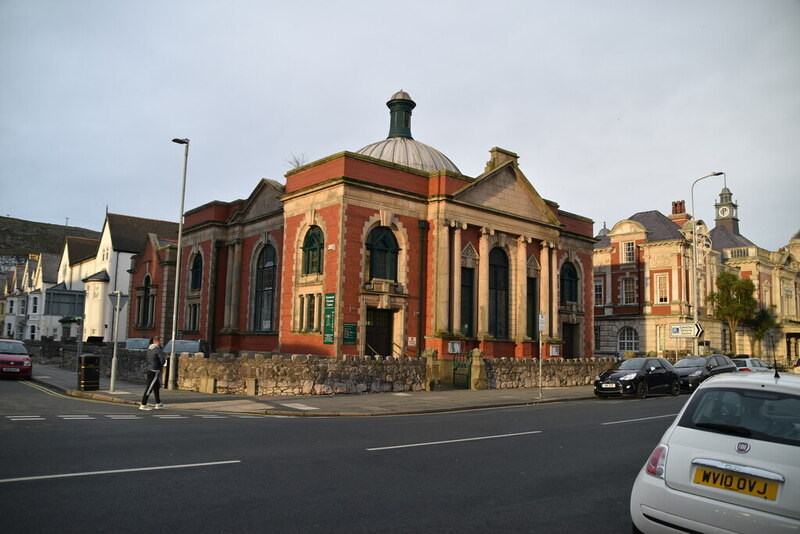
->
[678,388,800,446]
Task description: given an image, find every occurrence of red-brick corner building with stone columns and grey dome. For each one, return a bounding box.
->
[179,91,595,358]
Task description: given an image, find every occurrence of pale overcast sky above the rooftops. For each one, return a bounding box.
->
[0,0,800,250]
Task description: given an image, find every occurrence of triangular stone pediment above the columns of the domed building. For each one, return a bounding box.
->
[453,147,561,226]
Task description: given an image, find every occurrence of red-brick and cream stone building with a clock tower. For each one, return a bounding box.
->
[594,187,800,363]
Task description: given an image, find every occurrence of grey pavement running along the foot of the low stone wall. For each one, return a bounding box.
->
[33,364,594,417]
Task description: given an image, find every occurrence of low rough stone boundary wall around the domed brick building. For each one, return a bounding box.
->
[25,340,615,397]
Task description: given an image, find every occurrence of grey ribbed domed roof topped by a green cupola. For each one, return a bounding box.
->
[356,89,461,174]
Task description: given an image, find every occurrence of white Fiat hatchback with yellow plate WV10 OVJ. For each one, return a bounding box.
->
[630,373,800,534]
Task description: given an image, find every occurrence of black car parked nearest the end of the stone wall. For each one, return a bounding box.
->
[594,358,681,399]
